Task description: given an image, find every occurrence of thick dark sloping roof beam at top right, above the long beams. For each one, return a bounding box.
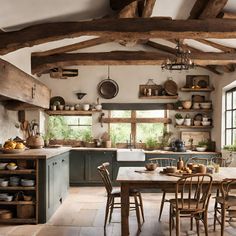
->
[198,0,228,19]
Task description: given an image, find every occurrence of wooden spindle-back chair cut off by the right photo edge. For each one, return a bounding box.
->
[214,179,236,236]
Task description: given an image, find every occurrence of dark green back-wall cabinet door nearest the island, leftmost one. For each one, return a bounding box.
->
[69,150,87,185]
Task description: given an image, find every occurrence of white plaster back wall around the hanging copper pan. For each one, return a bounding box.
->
[40,66,214,139]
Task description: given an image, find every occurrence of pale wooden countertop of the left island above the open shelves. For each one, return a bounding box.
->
[0,147,71,159]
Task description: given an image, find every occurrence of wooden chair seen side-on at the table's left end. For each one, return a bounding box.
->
[97,162,144,231]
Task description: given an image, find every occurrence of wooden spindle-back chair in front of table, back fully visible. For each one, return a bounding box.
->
[169,174,212,236]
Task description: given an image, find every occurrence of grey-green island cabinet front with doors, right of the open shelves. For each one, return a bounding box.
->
[46,153,69,220]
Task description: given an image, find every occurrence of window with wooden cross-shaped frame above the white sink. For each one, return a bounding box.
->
[108,110,169,144]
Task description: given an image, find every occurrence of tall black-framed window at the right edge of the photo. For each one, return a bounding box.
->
[225,88,236,145]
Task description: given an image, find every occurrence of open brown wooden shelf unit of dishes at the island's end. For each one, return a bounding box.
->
[0,158,38,224]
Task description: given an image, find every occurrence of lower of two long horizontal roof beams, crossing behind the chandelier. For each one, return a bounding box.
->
[31,51,236,74]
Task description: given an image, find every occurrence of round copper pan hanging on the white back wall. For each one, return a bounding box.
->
[98,66,119,99]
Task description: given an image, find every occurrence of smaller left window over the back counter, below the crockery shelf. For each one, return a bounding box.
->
[47,116,92,140]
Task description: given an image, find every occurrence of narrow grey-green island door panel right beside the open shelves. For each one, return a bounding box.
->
[46,160,54,219]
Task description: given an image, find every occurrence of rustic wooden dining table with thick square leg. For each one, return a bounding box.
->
[116,167,236,236]
